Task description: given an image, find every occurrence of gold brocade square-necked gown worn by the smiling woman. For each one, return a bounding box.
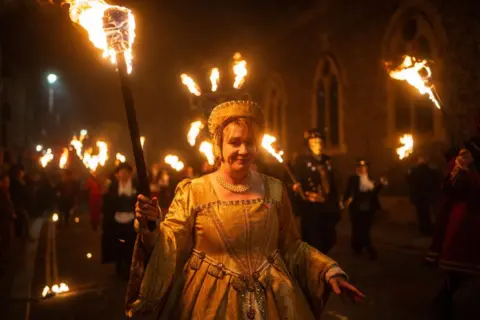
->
[130,176,335,320]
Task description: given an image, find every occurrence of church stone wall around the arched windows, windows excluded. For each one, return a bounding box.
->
[253,0,480,201]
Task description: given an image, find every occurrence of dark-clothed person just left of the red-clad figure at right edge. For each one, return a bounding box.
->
[407,156,441,236]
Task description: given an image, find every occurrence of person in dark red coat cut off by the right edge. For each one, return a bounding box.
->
[426,119,480,319]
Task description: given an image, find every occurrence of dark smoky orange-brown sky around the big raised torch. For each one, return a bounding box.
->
[3,0,315,165]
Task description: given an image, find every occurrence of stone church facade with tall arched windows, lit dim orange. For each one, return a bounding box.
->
[255,0,480,200]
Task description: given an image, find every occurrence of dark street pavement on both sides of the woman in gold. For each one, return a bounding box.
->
[0,210,480,320]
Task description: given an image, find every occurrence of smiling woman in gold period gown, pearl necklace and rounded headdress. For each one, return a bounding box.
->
[127,101,363,320]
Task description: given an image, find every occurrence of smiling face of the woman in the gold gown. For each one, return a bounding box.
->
[222,122,257,172]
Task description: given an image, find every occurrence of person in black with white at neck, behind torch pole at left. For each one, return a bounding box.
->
[102,162,137,278]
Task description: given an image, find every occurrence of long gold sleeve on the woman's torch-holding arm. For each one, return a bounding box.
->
[127,180,195,317]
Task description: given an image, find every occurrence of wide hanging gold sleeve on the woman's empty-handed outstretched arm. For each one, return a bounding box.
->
[278,185,346,313]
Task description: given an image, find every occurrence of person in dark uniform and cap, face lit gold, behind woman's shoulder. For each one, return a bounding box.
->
[293,129,340,253]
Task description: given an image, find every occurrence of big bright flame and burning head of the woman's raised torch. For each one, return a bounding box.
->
[66,0,135,73]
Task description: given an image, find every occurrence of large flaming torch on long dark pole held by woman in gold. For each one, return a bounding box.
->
[66,0,156,306]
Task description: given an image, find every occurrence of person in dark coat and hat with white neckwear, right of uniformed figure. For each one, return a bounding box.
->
[343,159,387,260]
